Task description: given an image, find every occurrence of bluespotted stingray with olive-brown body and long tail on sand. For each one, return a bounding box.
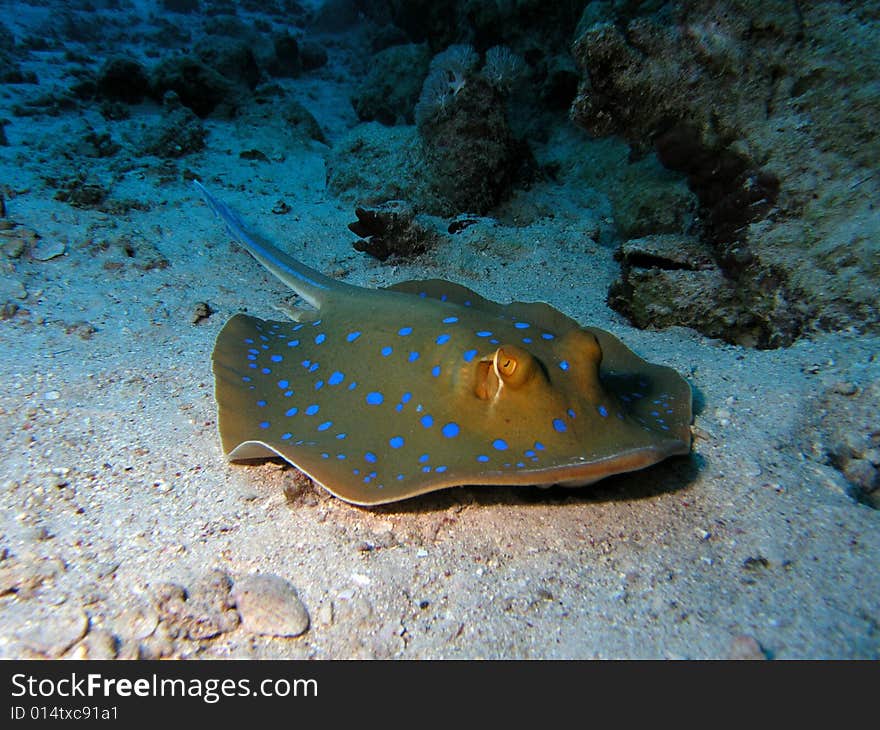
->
[196,183,691,505]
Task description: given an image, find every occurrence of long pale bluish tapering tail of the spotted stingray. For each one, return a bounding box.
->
[193,180,348,308]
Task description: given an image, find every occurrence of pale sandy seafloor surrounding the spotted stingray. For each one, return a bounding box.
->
[0,1,880,659]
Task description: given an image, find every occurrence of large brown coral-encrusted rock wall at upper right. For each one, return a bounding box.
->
[571,0,880,347]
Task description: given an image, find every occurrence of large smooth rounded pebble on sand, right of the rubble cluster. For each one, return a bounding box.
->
[232,573,309,636]
